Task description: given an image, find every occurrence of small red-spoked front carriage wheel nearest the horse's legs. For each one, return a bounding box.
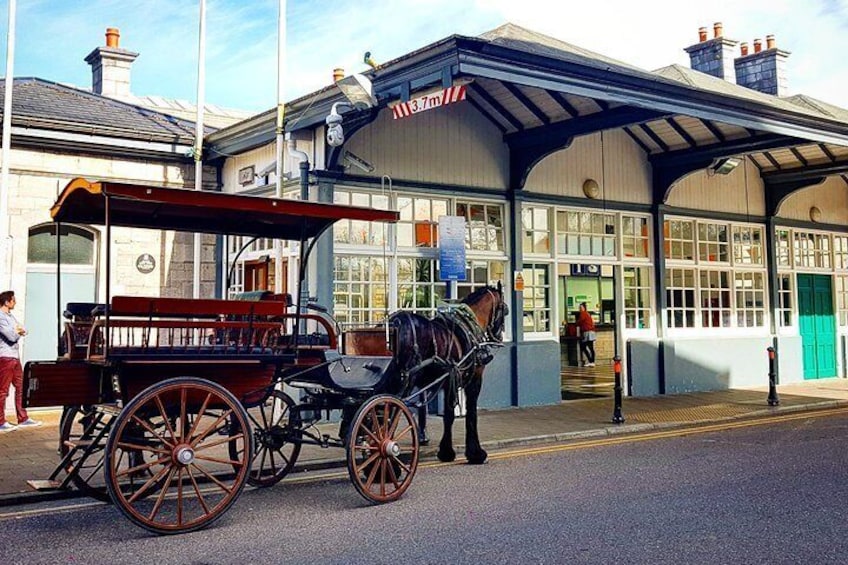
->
[347,395,418,502]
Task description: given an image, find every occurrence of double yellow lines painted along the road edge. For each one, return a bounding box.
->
[0,407,848,521]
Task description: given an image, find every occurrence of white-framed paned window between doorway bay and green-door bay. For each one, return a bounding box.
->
[664,218,767,328]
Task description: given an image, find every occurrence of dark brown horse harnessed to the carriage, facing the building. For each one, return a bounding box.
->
[389,282,509,464]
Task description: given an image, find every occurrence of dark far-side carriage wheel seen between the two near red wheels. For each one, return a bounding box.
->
[230,390,301,487]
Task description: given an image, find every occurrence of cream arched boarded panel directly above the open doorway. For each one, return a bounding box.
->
[525,131,651,204]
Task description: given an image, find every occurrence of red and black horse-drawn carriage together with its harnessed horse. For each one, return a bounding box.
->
[25,179,507,534]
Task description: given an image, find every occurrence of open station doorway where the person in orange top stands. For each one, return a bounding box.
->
[557,263,618,400]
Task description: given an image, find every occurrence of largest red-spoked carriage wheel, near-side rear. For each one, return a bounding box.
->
[105,377,253,534]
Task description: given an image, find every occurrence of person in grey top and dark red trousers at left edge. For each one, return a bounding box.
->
[0,290,41,433]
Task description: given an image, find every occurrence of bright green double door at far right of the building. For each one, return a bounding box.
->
[798,275,836,379]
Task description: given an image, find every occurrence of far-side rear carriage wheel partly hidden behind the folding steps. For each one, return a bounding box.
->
[59,406,166,502]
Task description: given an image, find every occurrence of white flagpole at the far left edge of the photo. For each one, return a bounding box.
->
[0,0,16,290]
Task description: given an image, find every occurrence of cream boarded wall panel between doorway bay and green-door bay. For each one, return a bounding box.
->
[666,160,766,216]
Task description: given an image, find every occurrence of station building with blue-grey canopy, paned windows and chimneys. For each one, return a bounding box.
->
[206,24,848,407]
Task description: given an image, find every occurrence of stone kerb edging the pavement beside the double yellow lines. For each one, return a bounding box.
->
[0,400,848,508]
